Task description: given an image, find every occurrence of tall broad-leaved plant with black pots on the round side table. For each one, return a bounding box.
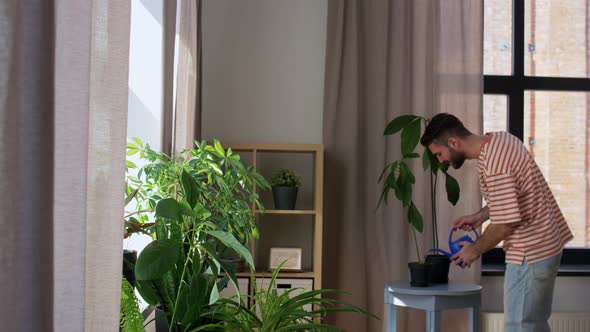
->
[379,115,460,286]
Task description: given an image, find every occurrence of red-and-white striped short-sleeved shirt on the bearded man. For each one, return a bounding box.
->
[477,132,573,264]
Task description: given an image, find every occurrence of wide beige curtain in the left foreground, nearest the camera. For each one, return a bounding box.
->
[0,0,130,331]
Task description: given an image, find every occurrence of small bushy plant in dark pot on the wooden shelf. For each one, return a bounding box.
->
[271,168,301,210]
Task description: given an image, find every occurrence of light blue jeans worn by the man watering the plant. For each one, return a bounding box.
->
[504,253,561,332]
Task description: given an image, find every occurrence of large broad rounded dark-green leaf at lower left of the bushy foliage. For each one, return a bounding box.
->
[135,240,179,280]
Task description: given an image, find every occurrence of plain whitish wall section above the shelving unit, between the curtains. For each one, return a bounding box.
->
[202,0,327,143]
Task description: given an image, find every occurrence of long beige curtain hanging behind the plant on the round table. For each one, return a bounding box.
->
[323,0,483,332]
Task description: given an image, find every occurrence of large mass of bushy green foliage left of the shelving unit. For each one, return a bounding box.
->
[128,140,270,331]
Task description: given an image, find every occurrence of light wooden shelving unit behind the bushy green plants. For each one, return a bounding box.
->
[222,142,324,298]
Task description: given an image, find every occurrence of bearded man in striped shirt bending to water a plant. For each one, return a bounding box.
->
[420,113,573,332]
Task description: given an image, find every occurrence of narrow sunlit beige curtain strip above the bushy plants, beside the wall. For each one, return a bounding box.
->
[170,0,202,151]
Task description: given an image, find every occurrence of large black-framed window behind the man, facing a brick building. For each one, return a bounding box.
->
[483,0,590,274]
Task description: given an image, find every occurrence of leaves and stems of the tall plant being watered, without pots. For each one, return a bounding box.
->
[378,115,460,260]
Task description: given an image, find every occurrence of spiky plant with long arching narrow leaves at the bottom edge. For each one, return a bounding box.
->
[198,262,376,332]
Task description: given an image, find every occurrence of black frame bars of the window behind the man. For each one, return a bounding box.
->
[482,0,590,276]
